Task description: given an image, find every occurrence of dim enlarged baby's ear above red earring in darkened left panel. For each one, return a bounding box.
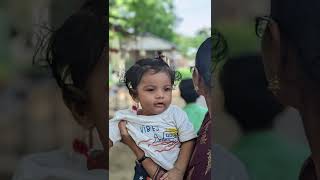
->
[67,102,94,129]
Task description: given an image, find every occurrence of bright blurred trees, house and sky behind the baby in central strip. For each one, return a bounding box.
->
[109,0,211,180]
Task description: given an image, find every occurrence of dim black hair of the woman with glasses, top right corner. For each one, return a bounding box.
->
[271,0,320,86]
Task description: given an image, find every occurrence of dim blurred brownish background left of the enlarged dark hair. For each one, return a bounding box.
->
[0,0,104,180]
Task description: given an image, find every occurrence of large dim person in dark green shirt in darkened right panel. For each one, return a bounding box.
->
[219,54,307,180]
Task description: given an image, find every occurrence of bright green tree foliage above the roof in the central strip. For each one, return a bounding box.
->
[109,0,211,60]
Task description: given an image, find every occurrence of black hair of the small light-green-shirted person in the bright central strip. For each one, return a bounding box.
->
[179,79,199,103]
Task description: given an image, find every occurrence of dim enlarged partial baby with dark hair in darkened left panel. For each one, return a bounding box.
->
[13,1,108,180]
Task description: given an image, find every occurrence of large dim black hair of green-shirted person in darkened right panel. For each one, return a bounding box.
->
[220,54,284,132]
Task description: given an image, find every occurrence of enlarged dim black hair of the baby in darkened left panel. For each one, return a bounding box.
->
[34,0,107,103]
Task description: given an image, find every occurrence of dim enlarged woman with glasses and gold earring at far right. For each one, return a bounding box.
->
[255,0,320,180]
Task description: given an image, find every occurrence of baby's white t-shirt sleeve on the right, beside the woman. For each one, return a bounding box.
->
[174,107,197,142]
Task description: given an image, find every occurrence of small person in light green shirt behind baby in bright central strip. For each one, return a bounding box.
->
[179,79,208,132]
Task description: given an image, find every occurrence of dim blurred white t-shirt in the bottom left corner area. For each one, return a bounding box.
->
[12,150,108,180]
